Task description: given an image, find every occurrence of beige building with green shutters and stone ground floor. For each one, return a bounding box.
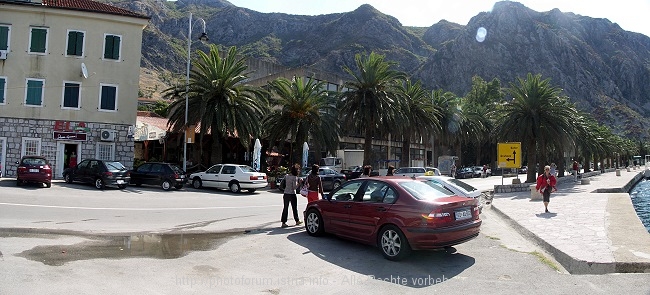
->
[0,0,149,178]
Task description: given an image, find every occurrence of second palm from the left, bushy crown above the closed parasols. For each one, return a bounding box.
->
[263,78,340,166]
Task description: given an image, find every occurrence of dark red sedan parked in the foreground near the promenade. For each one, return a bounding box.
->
[305,177,481,260]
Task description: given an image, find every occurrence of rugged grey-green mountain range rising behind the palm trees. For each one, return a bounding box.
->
[100,0,650,140]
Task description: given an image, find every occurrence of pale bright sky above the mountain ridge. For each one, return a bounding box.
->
[228,0,650,36]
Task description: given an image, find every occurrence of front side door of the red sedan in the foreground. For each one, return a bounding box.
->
[319,181,365,236]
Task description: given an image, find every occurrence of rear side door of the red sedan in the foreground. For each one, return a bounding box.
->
[348,180,397,244]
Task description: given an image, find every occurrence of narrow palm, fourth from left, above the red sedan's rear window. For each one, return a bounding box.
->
[396,80,442,165]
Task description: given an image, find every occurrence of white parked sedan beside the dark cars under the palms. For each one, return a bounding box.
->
[189,164,268,193]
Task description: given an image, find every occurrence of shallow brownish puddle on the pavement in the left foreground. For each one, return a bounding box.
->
[10,233,241,266]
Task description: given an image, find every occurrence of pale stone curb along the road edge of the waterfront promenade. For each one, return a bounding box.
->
[492,202,612,274]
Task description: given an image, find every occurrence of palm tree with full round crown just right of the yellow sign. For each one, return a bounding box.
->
[497,73,578,182]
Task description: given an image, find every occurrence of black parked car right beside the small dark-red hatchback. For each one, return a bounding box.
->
[63,159,131,189]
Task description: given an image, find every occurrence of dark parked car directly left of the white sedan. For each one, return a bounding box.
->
[131,162,187,191]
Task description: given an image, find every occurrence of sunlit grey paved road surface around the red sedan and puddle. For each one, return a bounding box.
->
[0,177,650,294]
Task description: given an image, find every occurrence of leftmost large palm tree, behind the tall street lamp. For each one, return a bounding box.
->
[165,44,268,163]
